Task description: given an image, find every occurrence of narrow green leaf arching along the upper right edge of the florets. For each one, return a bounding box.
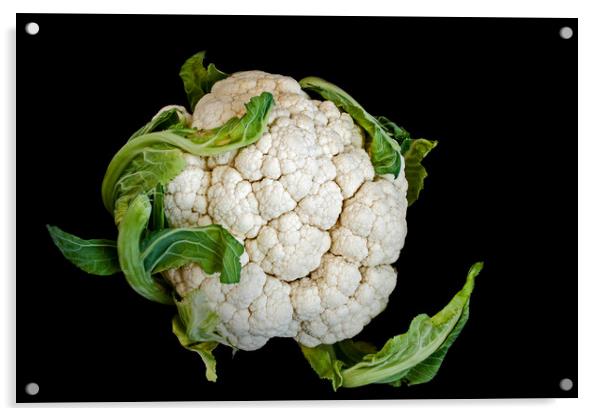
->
[299,77,403,177]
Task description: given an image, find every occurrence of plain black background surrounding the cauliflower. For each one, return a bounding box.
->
[16,14,577,402]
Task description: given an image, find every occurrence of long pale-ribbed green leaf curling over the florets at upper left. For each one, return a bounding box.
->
[102,92,274,213]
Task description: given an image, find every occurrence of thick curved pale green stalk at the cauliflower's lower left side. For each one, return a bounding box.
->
[117,194,173,305]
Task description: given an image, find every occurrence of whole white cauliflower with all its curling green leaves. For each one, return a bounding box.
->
[48,52,482,390]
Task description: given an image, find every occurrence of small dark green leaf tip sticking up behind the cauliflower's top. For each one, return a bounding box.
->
[180,51,228,111]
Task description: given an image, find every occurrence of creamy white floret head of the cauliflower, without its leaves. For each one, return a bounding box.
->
[165,71,407,350]
